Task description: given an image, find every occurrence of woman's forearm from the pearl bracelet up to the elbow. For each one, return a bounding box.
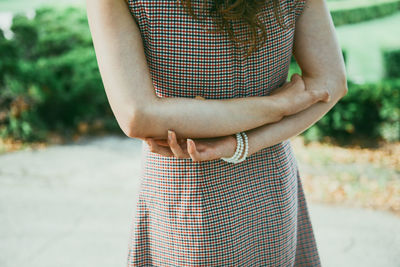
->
[246,78,347,155]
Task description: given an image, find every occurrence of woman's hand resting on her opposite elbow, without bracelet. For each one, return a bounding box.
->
[271,73,330,116]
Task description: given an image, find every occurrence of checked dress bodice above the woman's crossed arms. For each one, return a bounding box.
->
[129,0,296,99]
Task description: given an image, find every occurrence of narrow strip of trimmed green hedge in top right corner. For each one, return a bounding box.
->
[329,0,400,26]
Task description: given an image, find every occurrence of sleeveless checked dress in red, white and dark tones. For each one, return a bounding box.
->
[127,0,321,267]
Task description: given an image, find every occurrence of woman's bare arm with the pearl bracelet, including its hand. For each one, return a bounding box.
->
[143,0,348,161]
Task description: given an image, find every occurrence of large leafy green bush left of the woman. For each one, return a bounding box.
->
[0,6,118,141]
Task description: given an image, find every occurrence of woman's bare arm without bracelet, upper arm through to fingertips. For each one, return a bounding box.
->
[86,0,329,142]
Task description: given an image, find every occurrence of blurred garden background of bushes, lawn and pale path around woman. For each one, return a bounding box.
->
[0,0,400,267]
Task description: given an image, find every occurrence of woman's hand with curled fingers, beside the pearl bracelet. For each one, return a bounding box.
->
[145,131,236,161]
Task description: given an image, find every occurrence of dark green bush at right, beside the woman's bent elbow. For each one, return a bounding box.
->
[302,79,400,145]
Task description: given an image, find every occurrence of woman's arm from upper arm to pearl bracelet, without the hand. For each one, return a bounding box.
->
[246,0,348,155]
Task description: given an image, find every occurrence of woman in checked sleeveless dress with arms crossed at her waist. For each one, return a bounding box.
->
[86,0,347,266]
